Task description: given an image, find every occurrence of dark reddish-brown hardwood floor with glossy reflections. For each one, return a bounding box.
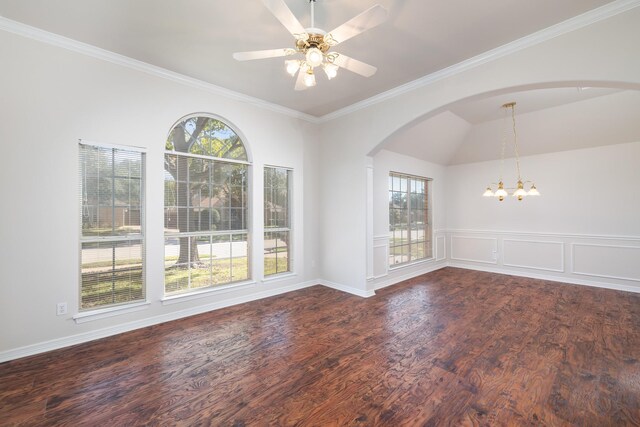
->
[0,268,640,426]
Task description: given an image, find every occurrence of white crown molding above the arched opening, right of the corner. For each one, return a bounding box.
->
[318,0,640,123]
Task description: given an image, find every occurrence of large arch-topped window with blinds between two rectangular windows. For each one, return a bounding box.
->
[164,113,252,297]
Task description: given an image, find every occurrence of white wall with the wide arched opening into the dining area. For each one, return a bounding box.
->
[321,8,640,289]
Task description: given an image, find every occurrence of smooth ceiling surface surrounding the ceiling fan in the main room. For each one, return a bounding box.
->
[0,0,611,117]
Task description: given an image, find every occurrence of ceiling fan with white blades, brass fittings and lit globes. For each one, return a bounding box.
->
[233,0,387,90]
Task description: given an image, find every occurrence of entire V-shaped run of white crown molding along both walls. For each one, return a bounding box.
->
[0,0,640,124]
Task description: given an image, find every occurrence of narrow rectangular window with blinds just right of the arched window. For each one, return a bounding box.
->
[264,166,293,276]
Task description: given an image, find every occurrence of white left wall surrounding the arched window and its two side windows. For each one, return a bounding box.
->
[0,32,319,361]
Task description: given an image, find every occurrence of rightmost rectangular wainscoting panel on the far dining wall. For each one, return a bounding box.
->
[571,243,640,282]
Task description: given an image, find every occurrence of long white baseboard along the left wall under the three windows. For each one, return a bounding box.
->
[0,280,322,363]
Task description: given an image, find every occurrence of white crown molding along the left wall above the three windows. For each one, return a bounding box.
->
[0,16,319,123]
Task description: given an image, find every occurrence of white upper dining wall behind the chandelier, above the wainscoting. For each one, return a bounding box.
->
[447,142,640,236]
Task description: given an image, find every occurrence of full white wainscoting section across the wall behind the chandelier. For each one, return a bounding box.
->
[445,229,640,293]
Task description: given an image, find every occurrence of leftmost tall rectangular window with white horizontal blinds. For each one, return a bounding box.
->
[79,142,145,311]
